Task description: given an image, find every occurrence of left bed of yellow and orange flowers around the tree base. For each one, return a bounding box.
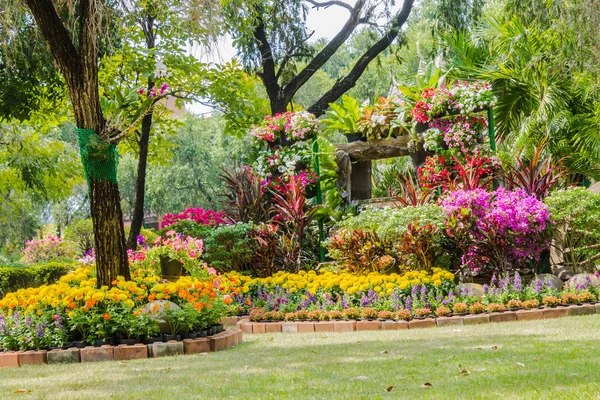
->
[0,268,237,350]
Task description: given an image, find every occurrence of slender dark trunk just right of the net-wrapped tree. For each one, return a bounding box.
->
[127,88,154,250]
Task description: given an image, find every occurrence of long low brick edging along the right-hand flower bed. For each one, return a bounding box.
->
[237,303,600,334]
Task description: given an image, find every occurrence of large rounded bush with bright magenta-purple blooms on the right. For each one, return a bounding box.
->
[442,187,552,272]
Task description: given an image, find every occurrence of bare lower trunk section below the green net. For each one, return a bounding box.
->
[89,178,131,287]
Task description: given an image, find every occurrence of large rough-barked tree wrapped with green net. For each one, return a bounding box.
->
[17,0,130,286]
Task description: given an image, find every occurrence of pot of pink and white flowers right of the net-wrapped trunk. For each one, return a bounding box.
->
[148,230,203,281]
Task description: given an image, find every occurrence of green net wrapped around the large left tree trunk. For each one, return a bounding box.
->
[76,128,119,187]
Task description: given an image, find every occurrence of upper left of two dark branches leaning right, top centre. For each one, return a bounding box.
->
[283,0,366,104]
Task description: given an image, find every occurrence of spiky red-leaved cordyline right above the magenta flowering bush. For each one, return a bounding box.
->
[503,143,567,200]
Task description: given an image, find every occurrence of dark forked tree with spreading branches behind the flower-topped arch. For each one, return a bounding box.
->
[225,0,414,115]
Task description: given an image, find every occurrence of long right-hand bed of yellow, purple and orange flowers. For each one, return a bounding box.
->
[221,269,599,322]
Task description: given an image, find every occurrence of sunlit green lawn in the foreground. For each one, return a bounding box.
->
[0,315,600,400]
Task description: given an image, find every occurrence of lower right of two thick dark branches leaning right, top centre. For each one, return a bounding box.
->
[308,0,414,116]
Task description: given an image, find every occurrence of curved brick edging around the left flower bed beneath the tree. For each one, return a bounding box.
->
[0,329,243,367]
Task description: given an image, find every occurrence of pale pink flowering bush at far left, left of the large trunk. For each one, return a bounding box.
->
[21,235,77,265]
